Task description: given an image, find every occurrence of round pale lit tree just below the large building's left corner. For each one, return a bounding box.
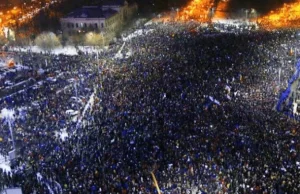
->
[34,32,61,52]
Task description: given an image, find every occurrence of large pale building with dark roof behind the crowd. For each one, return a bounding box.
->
[60,0,138,35]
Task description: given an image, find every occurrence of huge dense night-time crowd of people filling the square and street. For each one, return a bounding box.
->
[0,19,300,194]
